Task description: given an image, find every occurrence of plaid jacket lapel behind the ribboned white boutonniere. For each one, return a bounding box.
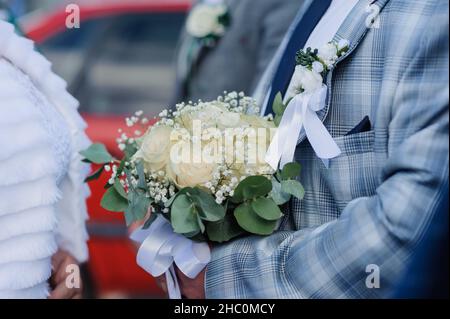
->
[298,0,390,144]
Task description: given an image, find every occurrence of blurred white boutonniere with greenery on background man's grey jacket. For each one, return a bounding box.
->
[186,2,231,46]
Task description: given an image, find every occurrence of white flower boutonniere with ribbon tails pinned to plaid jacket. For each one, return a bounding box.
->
[266,40,350,169]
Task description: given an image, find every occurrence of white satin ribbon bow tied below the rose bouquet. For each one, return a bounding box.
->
[131,216,211,299]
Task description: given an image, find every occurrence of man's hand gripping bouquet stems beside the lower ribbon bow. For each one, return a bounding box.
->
[155,268,206,299]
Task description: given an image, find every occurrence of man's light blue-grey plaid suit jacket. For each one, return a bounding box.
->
[205,0,449,298]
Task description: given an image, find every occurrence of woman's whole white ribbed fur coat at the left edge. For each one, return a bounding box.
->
[0,21,90,298]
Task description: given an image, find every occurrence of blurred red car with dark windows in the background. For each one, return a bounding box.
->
[20,0,190,297]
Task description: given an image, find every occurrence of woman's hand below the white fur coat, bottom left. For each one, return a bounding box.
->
[49,250,82,299]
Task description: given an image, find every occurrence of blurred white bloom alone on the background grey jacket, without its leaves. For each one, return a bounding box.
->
[186,4,223,38]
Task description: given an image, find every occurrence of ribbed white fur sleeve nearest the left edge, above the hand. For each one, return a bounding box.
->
[0,57,61,298]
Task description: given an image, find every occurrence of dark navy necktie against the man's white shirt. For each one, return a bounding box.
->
[265,0,332,115]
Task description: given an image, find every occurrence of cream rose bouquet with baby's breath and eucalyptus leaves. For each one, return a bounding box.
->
[81,92,304,242]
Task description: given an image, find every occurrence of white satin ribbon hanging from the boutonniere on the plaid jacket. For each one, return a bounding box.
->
[265,85,341,170]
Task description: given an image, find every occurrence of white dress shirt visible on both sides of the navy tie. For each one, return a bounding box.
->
[254,0,363,114]
